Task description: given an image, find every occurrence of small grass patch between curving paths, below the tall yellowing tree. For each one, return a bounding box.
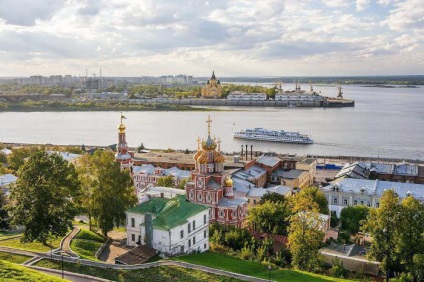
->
[71,229,106,260]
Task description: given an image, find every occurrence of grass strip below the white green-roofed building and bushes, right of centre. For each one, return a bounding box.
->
[173,252,351,282]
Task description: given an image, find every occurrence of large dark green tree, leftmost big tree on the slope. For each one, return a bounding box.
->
[10,151,79,244]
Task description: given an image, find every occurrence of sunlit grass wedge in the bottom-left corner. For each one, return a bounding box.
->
[0,260,68,282]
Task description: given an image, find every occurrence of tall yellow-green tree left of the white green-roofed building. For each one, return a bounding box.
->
[77,151,137,235]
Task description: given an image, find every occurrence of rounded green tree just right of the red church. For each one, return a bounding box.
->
[247,194,290,236]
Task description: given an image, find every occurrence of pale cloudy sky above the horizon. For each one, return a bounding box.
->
[0,0,424,78]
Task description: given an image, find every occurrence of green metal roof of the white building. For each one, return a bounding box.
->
[127,195,209,230]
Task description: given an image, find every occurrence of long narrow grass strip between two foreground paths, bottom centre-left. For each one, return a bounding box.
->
[35,259,240,282]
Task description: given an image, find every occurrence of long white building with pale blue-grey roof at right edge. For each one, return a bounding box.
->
[321,178,424,216]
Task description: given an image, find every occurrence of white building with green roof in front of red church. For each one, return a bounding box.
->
[126,195,209,255]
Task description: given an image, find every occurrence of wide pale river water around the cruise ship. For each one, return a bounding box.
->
[0,85,424,160]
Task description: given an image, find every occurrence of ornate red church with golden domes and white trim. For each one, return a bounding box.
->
[186,117,247,228]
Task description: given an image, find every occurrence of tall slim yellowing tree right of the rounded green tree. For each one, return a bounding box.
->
[288,193,324,271]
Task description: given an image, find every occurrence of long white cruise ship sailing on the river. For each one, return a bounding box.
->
[233,128,314,144]
